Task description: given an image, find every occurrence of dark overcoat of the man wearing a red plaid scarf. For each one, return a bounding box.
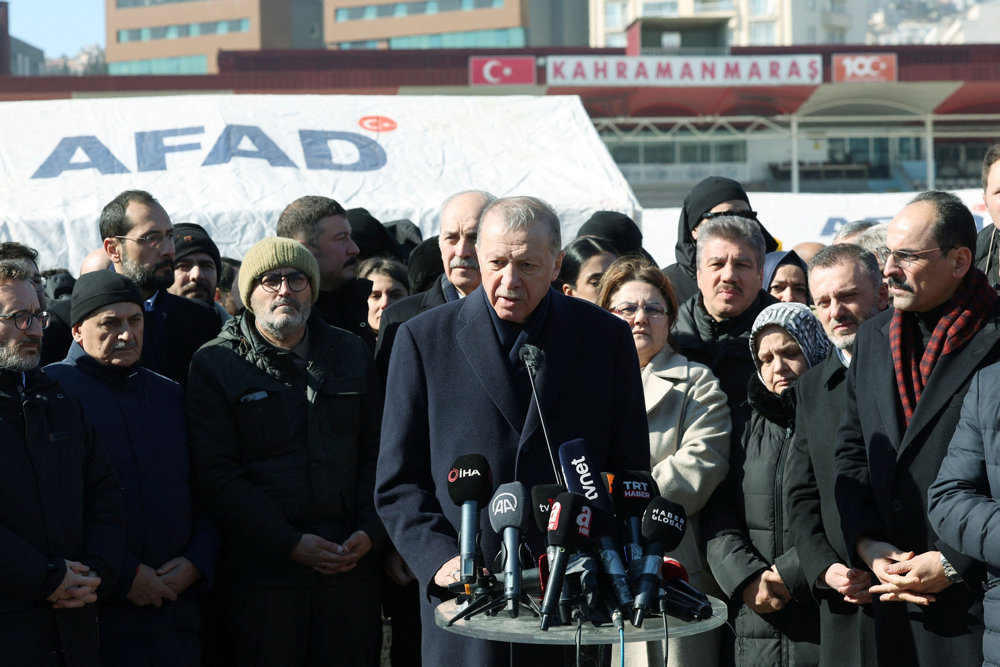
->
[835,311,1000,665]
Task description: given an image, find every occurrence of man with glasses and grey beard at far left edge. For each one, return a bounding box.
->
[0,260,124,665]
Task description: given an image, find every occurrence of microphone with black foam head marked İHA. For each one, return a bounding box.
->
[448,454,493,595]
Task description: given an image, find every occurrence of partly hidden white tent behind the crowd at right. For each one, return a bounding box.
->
[642,190,991,266]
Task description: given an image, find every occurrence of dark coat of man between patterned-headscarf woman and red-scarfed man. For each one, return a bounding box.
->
[785,348,876,665]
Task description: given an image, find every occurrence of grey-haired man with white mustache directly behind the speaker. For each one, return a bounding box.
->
[375,190,496,382]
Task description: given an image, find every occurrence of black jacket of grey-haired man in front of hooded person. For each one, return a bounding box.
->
[670,290,778,445]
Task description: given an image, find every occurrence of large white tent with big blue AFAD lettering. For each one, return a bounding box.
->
[0,95,639,273]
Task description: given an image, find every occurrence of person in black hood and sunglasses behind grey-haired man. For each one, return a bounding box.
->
[664,176,778,303]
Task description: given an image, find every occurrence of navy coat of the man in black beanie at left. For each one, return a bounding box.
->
[45,343,218,667]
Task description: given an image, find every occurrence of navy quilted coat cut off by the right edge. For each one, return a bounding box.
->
[928,365,1000,665]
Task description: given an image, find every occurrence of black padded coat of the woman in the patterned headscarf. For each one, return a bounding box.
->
[701,374,819,666]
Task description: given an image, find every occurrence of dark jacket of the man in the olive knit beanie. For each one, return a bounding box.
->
[187,311,385,586]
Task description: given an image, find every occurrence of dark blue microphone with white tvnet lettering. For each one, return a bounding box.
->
[559,438,632,620]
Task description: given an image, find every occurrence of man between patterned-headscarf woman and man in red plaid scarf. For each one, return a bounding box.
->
[785,243,889,665]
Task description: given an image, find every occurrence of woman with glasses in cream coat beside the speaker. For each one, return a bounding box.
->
[598,257,731,666]
